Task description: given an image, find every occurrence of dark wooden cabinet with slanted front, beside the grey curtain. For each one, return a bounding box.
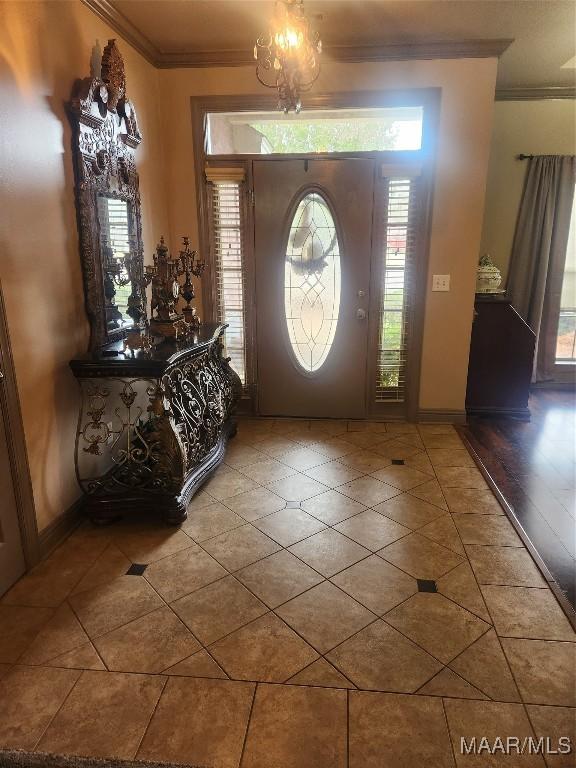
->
[466,294,535,420]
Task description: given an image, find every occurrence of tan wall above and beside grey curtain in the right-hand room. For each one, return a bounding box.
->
[480,100,576,280]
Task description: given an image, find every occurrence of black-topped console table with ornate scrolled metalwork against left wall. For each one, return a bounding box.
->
[70,323,242,524]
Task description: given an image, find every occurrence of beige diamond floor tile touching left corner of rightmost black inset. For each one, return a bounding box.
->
[331,555,418,615]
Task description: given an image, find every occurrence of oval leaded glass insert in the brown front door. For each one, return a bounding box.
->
[284,192,341,373]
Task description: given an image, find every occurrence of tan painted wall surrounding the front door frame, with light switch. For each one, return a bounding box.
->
[160,59,497,410]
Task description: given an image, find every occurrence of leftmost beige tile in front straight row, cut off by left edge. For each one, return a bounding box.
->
[0,667,81,750]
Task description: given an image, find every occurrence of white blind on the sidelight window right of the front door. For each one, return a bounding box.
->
[376,177,419,403]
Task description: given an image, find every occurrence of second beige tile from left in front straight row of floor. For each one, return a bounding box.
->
[38,672,165,759]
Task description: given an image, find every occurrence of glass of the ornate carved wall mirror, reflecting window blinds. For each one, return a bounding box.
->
[98,195,134,333]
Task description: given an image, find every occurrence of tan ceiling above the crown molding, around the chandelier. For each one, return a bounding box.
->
[103,0,576,89]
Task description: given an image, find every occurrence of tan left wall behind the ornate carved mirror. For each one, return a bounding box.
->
[0,1,167,529]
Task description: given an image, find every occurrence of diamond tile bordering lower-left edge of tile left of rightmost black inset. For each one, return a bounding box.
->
[276,581,376,653]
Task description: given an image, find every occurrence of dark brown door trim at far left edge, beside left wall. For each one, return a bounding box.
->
[0,281,40,570]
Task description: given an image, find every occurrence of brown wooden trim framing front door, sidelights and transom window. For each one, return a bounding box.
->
[190,93,442,421]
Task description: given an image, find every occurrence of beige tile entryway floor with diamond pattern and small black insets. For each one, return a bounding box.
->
[0,420,576,768]
